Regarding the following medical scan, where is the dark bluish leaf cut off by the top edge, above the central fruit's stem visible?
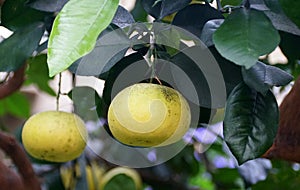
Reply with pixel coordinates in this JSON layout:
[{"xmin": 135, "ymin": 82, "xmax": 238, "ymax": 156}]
[{"xmin": 142, "ymin": 0, "xmax": 191, "ymax": 20}]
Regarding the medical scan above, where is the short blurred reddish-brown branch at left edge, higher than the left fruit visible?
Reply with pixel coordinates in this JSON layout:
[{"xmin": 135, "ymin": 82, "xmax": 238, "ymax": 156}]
[{"xmin": 0, "ymin": 64, "xmax": 26, "ymax": 99}]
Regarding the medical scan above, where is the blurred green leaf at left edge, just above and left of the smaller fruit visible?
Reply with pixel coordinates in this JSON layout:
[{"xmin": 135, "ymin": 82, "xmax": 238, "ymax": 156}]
[{"xmin": 0, "ymin": 93, "xmax": 30, "ymax": 118}]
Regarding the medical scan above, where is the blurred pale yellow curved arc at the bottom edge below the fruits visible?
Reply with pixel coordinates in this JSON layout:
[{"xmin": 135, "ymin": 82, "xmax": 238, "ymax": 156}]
[{"xmin": 100, "ymin": 167, "xmax": 142, "ymax": 190}]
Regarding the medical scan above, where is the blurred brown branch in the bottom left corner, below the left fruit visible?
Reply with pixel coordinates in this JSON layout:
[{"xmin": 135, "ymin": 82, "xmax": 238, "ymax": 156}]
[{"xmin": 0, "ymin": 132, "xmax": 41, "ymax": 190}]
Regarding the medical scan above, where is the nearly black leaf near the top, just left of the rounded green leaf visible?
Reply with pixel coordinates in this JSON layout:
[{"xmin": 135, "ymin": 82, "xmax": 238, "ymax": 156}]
[{"xmin": 172, "ymin": 4, "xmax": 224, "ymax": 37}]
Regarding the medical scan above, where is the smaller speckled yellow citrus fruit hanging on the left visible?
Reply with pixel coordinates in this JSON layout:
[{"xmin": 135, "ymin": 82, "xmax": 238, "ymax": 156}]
[{"xmin": 22, "ymin": 111, "xmax": 88, "ymax": 162}]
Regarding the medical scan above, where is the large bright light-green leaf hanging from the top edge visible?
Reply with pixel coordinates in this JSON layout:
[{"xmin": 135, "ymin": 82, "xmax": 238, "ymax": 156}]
[{"xmin": 48, "ymin": 0, "xmax": 119, "ymax": 76}]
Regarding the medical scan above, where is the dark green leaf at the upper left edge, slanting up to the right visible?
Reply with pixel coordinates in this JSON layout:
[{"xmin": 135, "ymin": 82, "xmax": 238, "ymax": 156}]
[{"xmin": 0, "ymin": 23, "xmax": 44, "ymax": 72}]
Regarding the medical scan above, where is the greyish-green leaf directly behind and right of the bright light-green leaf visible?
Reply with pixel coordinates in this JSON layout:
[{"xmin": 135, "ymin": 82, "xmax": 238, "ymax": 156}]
[{"xmin": 72, "ymin": 24, "xmax": 131, "ymax": 76}]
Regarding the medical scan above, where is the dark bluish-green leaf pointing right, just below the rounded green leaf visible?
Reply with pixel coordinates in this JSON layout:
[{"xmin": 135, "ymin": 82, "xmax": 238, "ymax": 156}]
[{"xmin": 242, "ymin": 62, "xmax": 293, "ymax": 94}]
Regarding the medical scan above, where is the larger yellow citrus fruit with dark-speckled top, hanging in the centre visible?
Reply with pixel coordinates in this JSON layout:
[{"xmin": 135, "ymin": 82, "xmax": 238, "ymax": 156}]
[{"xmin": 108, "ymin": 83, "xmax": 191, "ymax": 147}]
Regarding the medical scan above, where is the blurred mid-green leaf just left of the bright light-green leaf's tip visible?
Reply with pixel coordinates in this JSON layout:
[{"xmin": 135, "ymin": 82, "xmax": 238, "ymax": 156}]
[{"xmin": 26, "ymin": 54, "xmax": 55, "ymax": 96}]
